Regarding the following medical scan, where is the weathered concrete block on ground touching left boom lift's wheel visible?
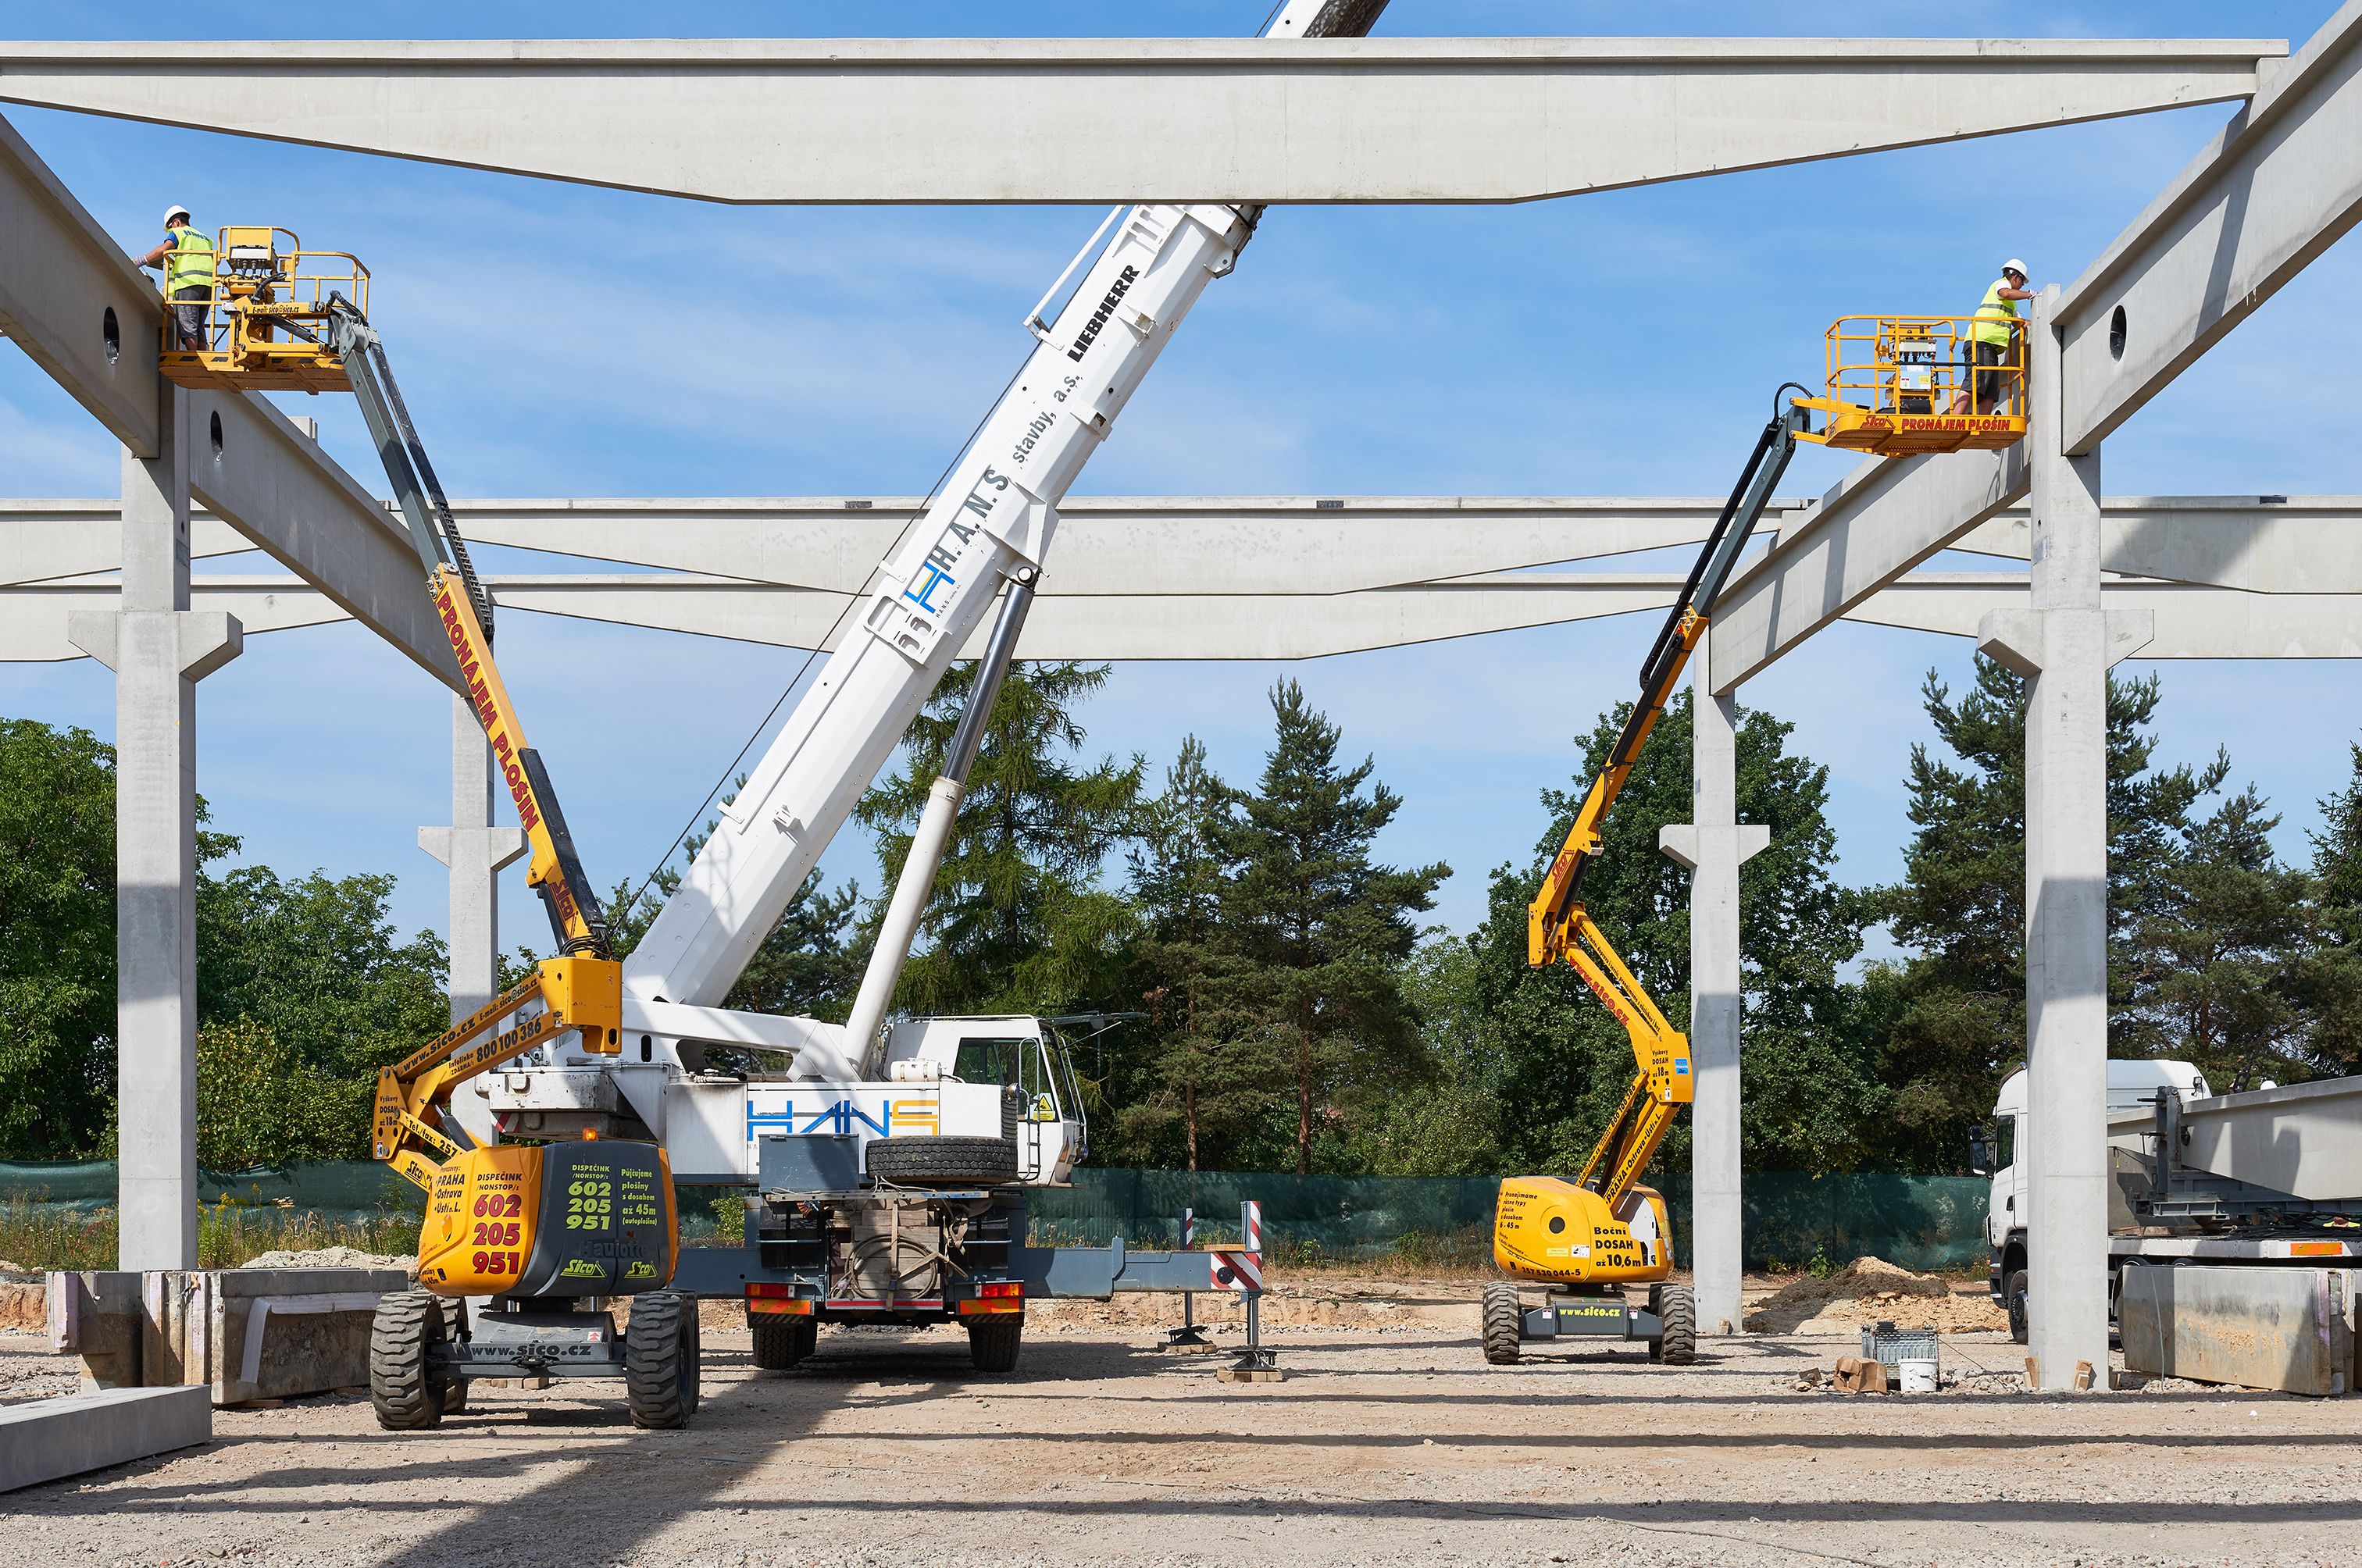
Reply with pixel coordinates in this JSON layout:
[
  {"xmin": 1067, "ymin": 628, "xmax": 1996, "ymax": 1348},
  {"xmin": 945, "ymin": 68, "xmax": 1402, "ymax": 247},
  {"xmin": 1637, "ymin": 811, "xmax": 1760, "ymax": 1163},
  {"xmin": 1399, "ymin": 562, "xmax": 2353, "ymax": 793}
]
[{"xmin": 141, "ymin": 1268, "xmax": 411, "ymax": 1405}]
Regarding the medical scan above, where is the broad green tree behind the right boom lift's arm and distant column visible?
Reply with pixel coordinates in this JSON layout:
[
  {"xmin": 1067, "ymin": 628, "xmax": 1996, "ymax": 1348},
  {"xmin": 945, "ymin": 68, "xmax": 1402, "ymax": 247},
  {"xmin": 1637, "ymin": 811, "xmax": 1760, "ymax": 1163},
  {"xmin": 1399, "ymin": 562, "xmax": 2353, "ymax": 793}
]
[{"xmin": 1469, "ymin": 692, "xmax": 1882, "ymax": 1174}]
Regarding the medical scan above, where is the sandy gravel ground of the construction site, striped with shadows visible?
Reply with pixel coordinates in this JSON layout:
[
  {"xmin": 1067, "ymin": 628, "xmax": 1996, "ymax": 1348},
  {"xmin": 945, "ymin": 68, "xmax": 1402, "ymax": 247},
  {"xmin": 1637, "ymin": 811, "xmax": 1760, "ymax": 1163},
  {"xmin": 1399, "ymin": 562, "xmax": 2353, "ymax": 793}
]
[{"xmin": 0, "ymin": 1278, "xmax": 2362, "ymax": 1568}]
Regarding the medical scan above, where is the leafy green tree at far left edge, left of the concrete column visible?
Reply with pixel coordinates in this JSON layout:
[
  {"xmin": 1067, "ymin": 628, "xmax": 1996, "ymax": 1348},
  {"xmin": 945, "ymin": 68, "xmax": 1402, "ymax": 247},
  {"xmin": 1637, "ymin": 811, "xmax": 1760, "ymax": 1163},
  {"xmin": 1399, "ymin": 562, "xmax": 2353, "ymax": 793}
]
[{"xmin": 0, "ymin": 718, "xmax": 116, "ymax": 1160}]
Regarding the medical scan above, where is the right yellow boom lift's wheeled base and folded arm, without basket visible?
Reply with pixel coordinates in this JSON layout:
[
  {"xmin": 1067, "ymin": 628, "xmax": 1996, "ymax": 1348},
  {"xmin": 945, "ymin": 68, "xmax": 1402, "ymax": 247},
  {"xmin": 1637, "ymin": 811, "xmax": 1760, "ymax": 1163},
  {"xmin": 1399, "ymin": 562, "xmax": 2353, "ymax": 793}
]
[{"xmin": 1483, "ymin": 387, "xmax": 1809, "ymax": 1365}]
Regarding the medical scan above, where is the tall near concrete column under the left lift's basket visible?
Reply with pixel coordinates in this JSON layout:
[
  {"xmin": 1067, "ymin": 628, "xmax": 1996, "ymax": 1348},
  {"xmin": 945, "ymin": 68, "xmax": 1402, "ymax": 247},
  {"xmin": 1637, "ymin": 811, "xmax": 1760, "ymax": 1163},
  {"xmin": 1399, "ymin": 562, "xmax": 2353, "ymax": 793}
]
[{"xmin": 66, "ymin": 385, "xmax": 243, "ymax": 1270}]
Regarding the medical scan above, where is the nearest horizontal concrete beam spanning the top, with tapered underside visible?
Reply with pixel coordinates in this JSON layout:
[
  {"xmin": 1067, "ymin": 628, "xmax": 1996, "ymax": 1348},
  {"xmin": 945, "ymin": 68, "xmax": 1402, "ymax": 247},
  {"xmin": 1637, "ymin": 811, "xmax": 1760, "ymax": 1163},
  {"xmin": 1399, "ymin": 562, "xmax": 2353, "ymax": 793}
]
[{"xmin": 0, "ymin": 37, "xmax": 2286, "ymax": 203}]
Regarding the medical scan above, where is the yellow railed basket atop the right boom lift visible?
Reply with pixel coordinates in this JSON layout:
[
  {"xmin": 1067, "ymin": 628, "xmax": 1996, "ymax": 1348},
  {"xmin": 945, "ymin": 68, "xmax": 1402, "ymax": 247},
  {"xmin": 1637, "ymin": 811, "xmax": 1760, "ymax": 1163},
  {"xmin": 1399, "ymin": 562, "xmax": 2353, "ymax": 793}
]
[{"xmin": 1795, "ymin": 316, "xmax": 2027, "ymax": 458}]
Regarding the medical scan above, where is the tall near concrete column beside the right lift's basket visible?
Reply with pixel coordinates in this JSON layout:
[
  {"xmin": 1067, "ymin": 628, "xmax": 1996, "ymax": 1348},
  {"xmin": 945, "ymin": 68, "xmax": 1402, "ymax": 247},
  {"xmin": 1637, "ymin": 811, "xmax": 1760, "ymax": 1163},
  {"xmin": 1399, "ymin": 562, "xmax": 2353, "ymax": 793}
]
[{"xmin": 1977, "ymin": 288, "xmax": 2152, "ymax": 1388}]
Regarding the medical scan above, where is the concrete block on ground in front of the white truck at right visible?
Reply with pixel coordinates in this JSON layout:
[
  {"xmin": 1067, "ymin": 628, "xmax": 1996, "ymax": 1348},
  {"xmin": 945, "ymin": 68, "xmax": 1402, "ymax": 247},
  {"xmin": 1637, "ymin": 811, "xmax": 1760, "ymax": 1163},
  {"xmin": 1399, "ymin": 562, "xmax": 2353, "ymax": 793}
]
[{"xmin": 2117, "ymin": 1268, "xmax": 2355, "ymax": 1395}]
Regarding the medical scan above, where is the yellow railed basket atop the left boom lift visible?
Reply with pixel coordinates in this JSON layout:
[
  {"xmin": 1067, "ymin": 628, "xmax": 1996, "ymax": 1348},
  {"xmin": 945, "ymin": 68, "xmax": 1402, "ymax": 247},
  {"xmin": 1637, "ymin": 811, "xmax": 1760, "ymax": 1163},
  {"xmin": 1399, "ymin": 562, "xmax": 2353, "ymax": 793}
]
[{"xmin": 156, "ymin": 224, "xmax": 369, "ymax": 394}]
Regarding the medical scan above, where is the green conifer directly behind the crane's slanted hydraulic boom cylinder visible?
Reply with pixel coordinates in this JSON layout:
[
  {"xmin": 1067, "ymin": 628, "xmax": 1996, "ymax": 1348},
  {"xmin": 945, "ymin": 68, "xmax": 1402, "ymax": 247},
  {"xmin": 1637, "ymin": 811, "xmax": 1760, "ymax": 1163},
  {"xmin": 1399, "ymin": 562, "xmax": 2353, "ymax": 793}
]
[{"xmin": 853, "ymin": 664, "xmax": 1148, "ymax": 1013}]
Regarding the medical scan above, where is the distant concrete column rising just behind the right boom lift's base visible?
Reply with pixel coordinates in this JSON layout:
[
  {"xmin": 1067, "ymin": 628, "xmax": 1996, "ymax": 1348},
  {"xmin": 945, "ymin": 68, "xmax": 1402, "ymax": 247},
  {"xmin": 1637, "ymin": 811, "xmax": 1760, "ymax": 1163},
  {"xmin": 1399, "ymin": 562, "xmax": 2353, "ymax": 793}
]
[{"xmin": 1656, "ymin": 633, "xmax": 1772, "ymax": 1335}]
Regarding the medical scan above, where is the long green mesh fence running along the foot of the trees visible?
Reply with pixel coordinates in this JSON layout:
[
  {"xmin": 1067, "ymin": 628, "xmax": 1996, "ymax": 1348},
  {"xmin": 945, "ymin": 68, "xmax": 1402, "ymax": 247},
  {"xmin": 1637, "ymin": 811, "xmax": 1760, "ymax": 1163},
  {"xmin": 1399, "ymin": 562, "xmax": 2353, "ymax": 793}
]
[{"xmin": 0, "ymin": 1160, "xmax": 1989, "ymax": 1268}]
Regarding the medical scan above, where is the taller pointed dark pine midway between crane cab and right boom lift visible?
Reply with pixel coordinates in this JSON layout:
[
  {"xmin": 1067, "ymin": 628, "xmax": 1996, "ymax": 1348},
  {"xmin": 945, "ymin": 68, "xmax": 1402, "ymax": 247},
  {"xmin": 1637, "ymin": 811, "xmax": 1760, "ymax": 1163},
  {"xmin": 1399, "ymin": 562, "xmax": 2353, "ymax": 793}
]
[{"xmin": 1214, "ymin": 680, "xmax": 1453, "ymax": 1176}]
